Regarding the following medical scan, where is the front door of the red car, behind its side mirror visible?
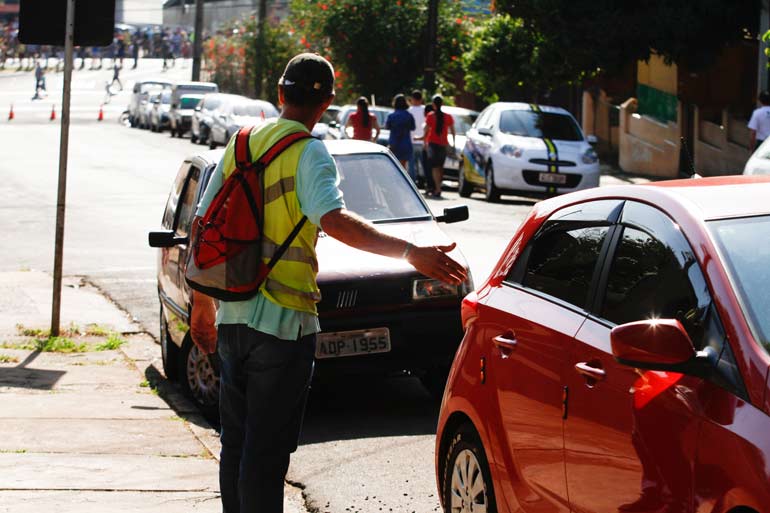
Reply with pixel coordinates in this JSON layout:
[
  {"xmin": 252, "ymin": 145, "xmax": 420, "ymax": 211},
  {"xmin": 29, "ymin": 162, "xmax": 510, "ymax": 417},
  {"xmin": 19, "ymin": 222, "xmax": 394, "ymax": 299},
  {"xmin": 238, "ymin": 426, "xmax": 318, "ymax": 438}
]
[{"xmin": 564, "ymin": 201, "xmax": 739, "ymax": 513}]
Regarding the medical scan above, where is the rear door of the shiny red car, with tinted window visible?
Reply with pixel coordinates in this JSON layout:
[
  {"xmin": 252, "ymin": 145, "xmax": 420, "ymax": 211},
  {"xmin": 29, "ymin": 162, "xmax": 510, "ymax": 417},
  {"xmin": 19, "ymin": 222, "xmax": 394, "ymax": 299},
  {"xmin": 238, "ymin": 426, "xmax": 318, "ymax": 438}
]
[{"xmin": 480, "ymin": 201, "xmax": 621, "ymax": 513}]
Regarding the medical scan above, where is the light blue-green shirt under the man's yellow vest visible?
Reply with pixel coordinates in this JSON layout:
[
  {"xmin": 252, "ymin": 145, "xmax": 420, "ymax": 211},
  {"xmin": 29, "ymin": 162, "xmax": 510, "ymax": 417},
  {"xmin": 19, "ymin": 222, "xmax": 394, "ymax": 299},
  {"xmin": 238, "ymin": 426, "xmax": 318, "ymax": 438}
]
[{"xmin": 196, "ymin": 118, "xmax": 345, "ymax": 340}]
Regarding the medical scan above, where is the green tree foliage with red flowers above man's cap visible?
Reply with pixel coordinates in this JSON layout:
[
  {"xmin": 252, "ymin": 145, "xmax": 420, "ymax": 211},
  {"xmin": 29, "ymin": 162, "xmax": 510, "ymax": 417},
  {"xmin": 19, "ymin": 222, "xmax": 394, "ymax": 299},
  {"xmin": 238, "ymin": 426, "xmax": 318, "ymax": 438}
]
[{"xmin": 291, "ymin": 0, "xmax": 471, "ymax": 103}]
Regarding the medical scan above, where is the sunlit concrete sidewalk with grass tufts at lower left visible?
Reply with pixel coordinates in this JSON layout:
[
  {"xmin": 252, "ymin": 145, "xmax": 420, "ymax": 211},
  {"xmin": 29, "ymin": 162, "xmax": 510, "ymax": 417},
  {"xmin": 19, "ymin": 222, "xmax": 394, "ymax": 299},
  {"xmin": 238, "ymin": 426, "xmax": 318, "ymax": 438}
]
[{"xmin": 0, "ymin": 272, "xmax": 305, "ymax": 513}]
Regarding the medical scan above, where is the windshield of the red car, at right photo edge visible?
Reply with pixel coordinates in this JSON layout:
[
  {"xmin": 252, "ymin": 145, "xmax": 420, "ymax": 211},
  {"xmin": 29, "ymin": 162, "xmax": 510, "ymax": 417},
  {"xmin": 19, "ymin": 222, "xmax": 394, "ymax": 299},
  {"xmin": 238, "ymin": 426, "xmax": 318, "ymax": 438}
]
[{"xmin": 708, "ymin": 216, "xmax": 770, "ymax": 352}]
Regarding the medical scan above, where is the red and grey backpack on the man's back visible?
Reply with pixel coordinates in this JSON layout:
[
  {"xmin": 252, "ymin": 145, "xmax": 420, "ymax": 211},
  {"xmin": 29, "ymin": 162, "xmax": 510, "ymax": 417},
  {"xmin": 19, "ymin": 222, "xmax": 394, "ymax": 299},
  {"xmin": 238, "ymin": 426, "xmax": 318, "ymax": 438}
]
[{"xmin": 185, "ymin": 127, "xmax": 311, "ymax": 301}]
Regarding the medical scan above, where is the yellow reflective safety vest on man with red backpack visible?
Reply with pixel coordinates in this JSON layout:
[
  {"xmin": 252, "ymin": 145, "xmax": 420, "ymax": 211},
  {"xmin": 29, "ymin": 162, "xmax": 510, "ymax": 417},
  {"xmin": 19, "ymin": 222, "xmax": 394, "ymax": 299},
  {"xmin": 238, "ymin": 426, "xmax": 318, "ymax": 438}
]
[{"xmin": 223, "ymin": 119, "xmax": 321, "ymax": 314}]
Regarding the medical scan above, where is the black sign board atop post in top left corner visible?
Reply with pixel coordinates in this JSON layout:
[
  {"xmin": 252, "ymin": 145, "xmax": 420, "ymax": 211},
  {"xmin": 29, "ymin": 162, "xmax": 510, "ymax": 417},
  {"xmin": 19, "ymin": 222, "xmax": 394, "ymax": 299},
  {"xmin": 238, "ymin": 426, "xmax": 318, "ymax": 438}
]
[{"xmin": 19, "ymin": 0, "xmax": 115, "ymax": 46}]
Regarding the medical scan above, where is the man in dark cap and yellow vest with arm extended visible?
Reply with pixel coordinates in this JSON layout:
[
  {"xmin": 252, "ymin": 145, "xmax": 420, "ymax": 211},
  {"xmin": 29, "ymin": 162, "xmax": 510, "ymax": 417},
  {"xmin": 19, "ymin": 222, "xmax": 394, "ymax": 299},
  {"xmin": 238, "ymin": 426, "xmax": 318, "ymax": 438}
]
[{"xmin": 190, "ymin": 53, "xmax": 467, "ymax": 513}]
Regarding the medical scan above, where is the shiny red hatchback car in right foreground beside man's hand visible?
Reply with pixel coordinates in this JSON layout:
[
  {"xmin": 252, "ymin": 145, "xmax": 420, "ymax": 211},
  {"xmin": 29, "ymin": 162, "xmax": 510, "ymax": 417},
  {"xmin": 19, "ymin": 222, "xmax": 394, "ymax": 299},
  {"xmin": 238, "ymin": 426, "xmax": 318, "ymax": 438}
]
[{"xmin": 436, "ymin": 177, "xmax": 770, "ymax": 513}]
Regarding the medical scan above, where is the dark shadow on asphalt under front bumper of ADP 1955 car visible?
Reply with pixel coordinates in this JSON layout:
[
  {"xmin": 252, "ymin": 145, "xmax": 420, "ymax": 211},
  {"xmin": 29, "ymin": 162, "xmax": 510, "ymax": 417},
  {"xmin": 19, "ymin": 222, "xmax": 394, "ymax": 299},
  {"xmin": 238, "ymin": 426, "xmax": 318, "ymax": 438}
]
[{"xmin": 300, "ymin": 376, "xmax": 439, "ymax": 445}]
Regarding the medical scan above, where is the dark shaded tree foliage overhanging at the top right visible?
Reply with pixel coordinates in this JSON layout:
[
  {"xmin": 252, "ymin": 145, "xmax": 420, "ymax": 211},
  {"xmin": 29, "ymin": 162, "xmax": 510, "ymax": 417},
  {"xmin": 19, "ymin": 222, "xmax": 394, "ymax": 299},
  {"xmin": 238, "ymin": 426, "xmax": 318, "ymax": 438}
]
[{"xmin": 496, "ymin": 0, "xmax": 760, "ymax": 73}]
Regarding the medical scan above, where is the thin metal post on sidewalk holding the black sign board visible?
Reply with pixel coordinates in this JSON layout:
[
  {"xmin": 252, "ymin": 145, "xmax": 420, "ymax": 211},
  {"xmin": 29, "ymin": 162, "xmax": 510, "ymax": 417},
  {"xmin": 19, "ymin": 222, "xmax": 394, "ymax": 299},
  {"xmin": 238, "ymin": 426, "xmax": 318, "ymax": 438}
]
[{"xmin": 51, "ymin": 0, "xmax": 75, "ymax": 337}]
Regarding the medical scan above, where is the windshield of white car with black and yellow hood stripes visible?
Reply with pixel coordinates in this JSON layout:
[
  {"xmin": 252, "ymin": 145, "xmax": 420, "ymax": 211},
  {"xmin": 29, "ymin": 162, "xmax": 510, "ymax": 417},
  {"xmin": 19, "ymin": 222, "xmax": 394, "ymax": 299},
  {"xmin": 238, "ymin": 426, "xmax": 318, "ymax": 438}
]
[{"xmin": 500, "ymin": 110, "xmax": 583, "ymax": 141}]
